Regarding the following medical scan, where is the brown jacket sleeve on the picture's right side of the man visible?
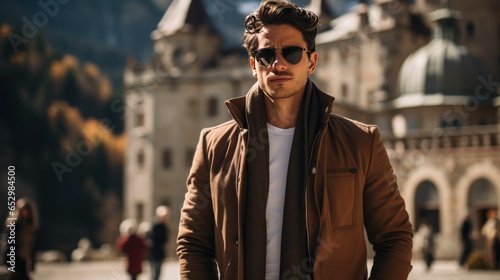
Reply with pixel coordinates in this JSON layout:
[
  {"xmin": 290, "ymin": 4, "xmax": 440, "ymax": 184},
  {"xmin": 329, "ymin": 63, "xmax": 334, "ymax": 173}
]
[{"xmin": 363, "ymin": 126, "xmax": 413, "ymax": 280}]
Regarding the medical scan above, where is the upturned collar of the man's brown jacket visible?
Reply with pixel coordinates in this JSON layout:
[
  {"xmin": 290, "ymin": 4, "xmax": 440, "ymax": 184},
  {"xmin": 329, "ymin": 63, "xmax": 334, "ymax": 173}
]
[{"xmin": 225, "ymin": 79, "xmax": 335, "ymax": 129}]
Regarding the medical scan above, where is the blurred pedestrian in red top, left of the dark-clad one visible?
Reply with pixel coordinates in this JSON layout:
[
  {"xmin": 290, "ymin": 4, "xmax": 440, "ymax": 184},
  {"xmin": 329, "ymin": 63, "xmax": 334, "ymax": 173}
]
[{"xmin": 116, "ymin": 219, "xmax": 148, "ymax": 280}]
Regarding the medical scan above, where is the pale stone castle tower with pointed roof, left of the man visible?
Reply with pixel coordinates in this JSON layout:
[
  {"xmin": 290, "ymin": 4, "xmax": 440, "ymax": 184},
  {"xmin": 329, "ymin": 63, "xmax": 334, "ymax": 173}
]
[{"xmin": 124, "ymin": 0, "xmax": 255, "ymax": 255}]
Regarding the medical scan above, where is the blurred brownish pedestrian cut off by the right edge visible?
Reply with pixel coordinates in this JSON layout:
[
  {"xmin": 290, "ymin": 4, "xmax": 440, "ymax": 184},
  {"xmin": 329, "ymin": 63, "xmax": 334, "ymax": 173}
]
[{"xmin": 481, "ymin": 209, "xmax": 500, "ymax": 269}]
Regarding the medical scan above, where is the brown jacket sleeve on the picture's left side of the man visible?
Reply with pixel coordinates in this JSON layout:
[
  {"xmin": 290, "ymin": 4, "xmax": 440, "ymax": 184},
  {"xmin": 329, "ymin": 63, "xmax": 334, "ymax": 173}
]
[{"xmin": 177, "ymin": 131, "xmax": 218, "ymax": 280}]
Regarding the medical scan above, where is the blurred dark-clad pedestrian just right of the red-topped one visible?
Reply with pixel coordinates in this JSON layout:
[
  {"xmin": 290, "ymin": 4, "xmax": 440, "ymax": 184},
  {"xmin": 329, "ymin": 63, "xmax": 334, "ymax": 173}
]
[{"xmin": 149, "ymin": 205, "xmax": 170, "ymax": 280}]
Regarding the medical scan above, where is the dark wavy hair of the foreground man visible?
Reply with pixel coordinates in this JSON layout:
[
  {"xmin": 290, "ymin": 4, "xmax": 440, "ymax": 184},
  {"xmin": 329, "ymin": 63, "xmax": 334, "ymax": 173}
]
[{"xmin": 242, "ymin": 0, "xmax": 319, "ymax": 55}]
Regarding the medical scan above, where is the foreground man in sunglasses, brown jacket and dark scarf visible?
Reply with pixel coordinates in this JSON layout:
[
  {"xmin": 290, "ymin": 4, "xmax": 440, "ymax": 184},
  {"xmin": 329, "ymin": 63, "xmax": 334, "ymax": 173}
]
[{"xmin": 177, "ymin": 1, "xmax": 413, "ymax": 280}]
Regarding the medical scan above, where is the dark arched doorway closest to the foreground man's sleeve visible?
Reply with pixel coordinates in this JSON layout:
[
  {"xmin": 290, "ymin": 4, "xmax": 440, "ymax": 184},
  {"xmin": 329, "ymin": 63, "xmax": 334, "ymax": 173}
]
[{"xmin": 414, "ymin": 181, "xmax": 441, "ymax": 233}]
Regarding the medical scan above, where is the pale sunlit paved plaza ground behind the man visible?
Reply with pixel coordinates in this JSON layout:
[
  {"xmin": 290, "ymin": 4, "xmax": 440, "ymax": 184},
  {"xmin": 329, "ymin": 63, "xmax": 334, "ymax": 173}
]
[{"xmin": 0, "ymin": 260, "xmax": 500, "ymax": 280}]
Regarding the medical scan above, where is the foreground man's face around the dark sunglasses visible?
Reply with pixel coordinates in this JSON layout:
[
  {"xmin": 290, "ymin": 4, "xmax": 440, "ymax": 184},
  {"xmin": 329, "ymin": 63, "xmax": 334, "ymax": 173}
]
[{"xmin": 250, "ymin": 24, "xmax": 318, "ymax": 99}]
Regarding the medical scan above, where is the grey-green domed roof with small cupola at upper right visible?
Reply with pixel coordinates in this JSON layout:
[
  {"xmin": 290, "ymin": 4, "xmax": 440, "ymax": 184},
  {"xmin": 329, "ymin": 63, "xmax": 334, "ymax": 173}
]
[{"xmin": 398, "ymin": 5, "xmax": 488, "ymax": 105}]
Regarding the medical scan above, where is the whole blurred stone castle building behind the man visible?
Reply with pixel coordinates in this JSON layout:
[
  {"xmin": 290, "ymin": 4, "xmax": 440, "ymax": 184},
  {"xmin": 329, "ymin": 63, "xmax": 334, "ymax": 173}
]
[{"xmin": 124, "ymin": 0, "xmax": 500, "ymax": 258}]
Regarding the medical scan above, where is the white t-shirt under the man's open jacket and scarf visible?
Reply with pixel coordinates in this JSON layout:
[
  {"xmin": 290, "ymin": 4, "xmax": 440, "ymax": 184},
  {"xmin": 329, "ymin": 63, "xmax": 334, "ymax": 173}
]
[{"xmin": 266, "ymin": 124, "xmax": 295, "ymax": 280}]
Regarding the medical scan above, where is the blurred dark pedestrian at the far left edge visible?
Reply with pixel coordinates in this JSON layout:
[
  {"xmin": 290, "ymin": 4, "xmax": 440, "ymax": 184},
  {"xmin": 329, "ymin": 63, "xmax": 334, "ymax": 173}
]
[{"xmin": 2, "ymin": 198, "xmax": 38, "ymax": 280}]
